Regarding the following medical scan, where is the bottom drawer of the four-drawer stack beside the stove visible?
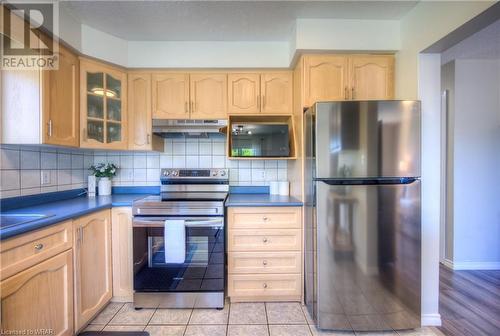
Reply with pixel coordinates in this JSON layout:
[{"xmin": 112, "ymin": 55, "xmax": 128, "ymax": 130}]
[{"xmin": 228, "ymin": 274, "xmax": 302, "ymax": 302}]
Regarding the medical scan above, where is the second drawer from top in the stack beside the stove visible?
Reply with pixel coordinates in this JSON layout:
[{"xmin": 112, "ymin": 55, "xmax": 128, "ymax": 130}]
[{"xmin": 228, "ymin": 229, "xmax": 302, "ymax": 252}]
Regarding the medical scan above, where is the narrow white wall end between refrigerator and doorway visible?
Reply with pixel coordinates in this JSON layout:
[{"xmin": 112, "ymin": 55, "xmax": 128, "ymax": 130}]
[{"xmin": 418, "ymin": 54, "xmax": 441, "ymax": 325}]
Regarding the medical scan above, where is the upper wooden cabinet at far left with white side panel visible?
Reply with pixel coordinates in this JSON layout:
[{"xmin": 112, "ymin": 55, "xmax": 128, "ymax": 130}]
[{"xmin": 0, "ymin": 45, "xmax": 80, "ymax": 147}]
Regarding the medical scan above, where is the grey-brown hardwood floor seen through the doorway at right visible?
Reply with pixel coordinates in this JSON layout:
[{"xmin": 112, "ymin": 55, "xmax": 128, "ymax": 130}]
[{"xmin": 439, "ymin": 265, "xmax": 500, "ymax": 336}]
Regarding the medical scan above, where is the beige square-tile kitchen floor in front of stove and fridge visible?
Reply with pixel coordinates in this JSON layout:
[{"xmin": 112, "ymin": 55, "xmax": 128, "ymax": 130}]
[{"xmin": 85, "ymin": 302, "xmax": 443, "ymax": 336}]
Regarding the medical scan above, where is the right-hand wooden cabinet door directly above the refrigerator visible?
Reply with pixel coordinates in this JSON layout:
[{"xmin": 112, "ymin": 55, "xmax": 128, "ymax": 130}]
[{"xmin": 349, "ymin": 55, "xmax": 394, "ymax": 100}]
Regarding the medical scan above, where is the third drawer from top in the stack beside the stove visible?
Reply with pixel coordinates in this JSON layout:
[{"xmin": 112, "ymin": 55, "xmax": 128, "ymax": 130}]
[{"xmin": 227, "ymin": 252, "xmax": 301, "ymax": 274}]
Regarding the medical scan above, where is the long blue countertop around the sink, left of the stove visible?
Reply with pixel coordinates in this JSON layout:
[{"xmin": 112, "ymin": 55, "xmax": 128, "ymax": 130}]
[{"xmin": 0, "ymin": 194, "xmax": 148, "ymax": 240}]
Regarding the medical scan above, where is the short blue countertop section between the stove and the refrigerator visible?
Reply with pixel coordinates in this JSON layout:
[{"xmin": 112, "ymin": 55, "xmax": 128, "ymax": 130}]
[{"xmin": 226, "ymin": 194, "xmax": 302, "ymax": 207}]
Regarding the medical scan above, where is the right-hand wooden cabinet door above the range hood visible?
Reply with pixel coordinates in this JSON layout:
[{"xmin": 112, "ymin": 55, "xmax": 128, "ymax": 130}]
[{"xmin": 190, "ymin": 73, "xmax": 227, "ymax": 119}]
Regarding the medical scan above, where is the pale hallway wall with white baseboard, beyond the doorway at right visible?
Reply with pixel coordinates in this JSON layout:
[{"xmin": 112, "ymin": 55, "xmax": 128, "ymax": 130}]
[{"xmin": 453, "ymin": 60, "xmax": 500, "ymax": 269}]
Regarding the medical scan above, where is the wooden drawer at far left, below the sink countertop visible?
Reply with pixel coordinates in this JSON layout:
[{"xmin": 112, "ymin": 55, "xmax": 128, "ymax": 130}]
[{"xmin": 0, "ymin": 221, "xmax": 73, "ymax": 280}]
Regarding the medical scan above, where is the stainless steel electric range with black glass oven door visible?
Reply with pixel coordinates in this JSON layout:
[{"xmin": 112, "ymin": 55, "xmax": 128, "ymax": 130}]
[{"xmin": 132, "ymin": 169, "xmax": 229, "ymax": 308}]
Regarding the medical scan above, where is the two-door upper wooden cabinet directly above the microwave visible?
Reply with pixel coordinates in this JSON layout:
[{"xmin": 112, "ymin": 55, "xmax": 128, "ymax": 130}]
[{"xmin": 228, "ymin": 72, "xmax": 292, "ymax": 114}]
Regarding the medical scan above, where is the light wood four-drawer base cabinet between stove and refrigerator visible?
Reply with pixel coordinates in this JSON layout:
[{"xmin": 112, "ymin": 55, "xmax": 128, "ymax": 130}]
[{"xmin": 227, "ymin": 207, "xmax": 302, "ymax": 302}]
